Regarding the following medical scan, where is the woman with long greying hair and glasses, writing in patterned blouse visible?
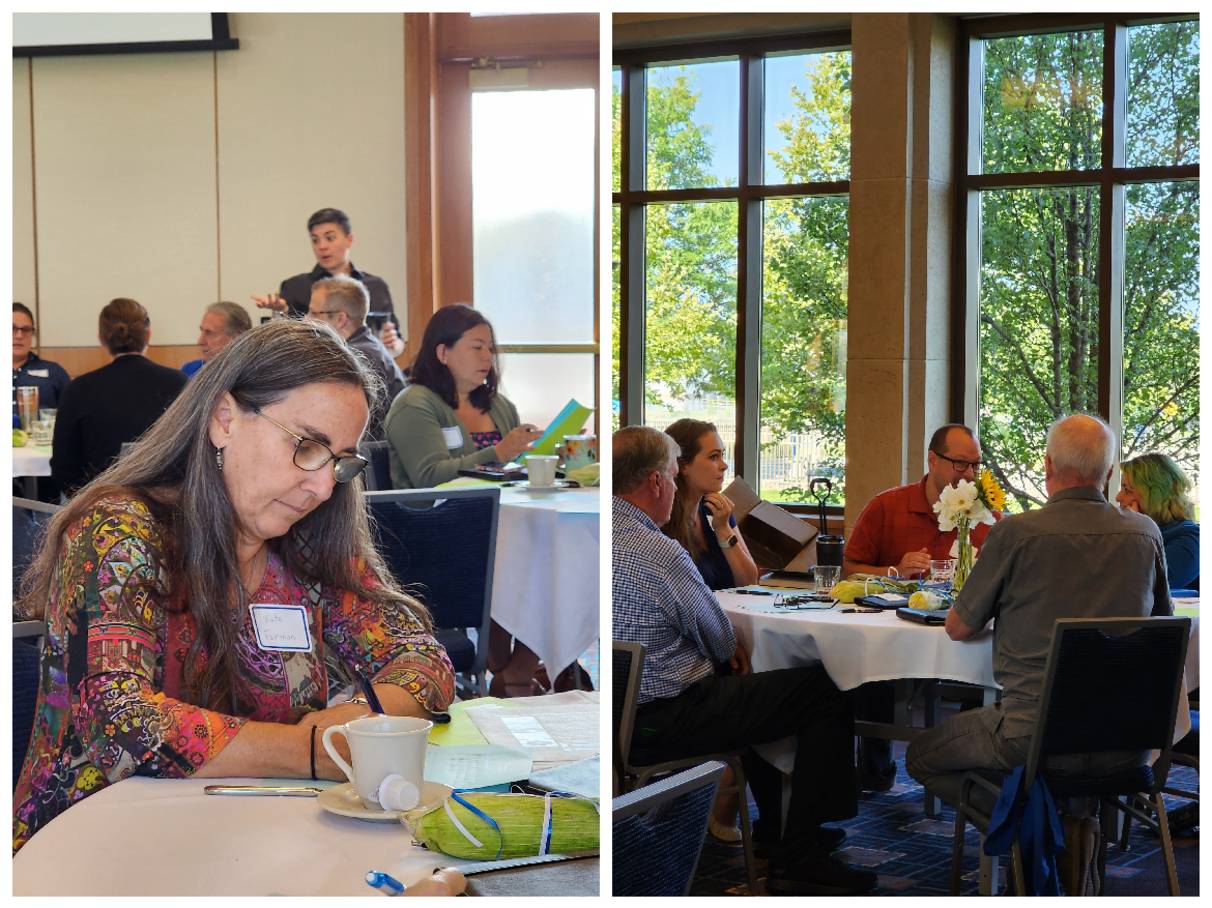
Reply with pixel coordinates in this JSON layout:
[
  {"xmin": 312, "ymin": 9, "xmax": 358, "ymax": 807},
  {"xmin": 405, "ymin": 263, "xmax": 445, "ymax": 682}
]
[{"xmin": 13, "ymin": 320, "xmax": 455, "ymax": 887}]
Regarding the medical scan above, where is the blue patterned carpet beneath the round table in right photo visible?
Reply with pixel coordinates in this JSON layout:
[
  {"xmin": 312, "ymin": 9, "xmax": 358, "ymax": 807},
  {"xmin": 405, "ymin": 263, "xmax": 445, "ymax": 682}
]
[{"xmin": 690, "ymin": 744, "xmax": 1199, "ymax": 896}]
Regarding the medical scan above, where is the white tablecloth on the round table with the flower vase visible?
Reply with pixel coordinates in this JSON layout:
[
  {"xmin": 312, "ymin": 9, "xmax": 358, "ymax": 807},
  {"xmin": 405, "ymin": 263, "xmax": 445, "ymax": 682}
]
[{"xmin": 718, "ymin": 592, "xmax": 997, "ymax": 691}]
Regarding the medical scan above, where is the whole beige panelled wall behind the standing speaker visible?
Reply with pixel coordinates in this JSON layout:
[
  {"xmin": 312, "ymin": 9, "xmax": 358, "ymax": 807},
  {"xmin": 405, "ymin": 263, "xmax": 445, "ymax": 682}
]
[{"xmin": 13, "ymin": 13, "xmax": 405, "ymax": 359}]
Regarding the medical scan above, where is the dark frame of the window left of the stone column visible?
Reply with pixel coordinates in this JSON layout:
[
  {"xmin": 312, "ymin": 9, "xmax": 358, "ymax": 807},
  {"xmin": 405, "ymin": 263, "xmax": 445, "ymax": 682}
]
[{"xmin": 612, "ymin": 29, "xmax": 851, "ymax": 513}]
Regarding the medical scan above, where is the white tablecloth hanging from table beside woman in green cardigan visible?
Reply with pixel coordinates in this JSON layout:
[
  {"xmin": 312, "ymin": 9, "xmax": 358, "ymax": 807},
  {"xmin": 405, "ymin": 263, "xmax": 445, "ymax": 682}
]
[{"xmin": 492, "ymin": 487, "xmax": 601, "ymax": 678}]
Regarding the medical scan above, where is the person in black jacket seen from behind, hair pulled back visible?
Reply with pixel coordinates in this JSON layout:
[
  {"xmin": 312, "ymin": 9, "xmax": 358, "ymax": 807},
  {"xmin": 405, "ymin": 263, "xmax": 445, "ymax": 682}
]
[{"xmin": 51, "ymin": 298, "xmax": 189, "ymax": 496}]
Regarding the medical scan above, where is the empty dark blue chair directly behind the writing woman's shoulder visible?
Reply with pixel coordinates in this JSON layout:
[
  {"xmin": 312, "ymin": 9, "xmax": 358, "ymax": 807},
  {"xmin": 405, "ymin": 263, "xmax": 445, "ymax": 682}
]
[{"xmin": 366, "ymin": 487, "xmax": 501, "ymax": 696}]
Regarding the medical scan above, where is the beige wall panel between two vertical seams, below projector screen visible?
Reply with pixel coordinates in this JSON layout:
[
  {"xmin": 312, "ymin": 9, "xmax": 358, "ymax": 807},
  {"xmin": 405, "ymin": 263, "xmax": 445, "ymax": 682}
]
[{"xmin": 33, "ymin": 53, "xmax": 218, "ymax": 346}]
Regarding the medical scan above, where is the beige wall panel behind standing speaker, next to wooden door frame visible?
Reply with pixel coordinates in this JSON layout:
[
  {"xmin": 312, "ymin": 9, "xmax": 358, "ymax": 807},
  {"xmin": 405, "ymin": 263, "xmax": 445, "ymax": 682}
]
[{"xmin": 217, "ymin": 13, "xmax": 406, "ymax": 337}]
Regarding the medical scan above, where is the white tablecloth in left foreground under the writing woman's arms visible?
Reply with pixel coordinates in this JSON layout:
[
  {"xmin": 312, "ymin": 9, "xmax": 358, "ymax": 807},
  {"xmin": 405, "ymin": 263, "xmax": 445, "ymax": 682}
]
[{"xmin": 12, "ymin": 777, "xmax": 450, "ymax": 898}]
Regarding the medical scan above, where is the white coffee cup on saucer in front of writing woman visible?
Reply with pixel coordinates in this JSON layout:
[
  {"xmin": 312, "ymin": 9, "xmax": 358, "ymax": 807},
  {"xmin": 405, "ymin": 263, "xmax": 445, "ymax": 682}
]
[{"xmin": 324, "ymin": 715, "xmax": 434, "ymax": 810}]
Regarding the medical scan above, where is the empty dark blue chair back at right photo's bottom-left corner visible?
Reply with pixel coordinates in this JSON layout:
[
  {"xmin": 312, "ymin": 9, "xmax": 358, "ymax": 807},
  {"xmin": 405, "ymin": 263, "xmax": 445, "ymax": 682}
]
[{"xmin": 611, "ymin": 761, "xmax": 724, "ymax": 896}]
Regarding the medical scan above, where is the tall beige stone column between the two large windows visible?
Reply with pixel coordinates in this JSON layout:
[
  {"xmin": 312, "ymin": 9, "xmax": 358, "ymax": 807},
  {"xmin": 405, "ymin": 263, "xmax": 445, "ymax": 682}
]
[{"xmin": 846, "ymin": 13, "xmax": 955, "ymax": 531}]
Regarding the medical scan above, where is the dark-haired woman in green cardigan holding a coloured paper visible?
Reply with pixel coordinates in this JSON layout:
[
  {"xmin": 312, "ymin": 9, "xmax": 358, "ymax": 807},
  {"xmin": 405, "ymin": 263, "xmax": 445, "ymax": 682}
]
[{"xmin": 383, "ymin": 303, "xmax": 542, "ymax": 696}]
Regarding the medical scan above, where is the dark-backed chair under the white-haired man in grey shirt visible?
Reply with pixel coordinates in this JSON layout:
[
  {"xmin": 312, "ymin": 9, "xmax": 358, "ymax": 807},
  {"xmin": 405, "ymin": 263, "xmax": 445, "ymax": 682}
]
[{"xmin": 930, "ymin": 617, "xmax": 1190, "ymax": 896}]
